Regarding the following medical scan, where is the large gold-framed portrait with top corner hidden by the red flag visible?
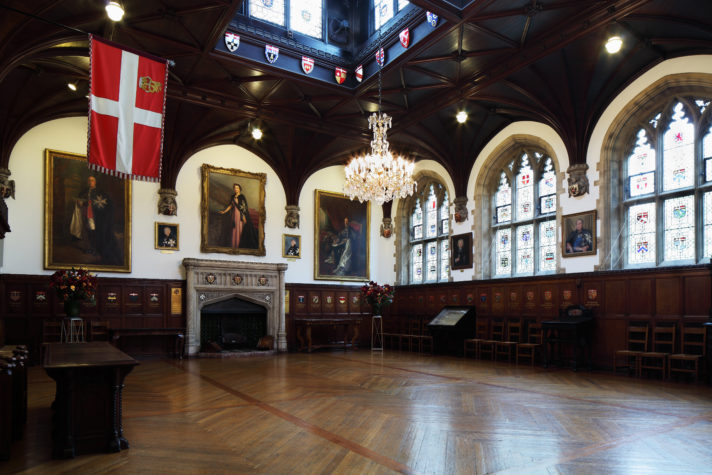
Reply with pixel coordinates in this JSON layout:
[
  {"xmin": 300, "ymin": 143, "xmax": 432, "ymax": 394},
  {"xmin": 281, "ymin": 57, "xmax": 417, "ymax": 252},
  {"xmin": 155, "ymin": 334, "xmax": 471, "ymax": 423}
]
[{"xmin": 44, "ymin": 150, "xmax": 131, "ymax": 272}]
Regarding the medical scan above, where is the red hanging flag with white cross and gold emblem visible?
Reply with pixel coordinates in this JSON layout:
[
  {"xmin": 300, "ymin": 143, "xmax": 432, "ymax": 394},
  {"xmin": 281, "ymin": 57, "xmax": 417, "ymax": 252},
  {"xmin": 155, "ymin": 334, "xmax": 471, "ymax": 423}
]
[{"xmin": 87, "ymin": 35, "xmax": 168, "ymax": 182}]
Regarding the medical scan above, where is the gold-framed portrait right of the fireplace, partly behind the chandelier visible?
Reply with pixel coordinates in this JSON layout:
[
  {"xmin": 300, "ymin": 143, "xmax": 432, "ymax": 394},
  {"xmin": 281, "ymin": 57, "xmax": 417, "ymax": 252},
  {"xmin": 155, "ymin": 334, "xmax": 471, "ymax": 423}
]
[{"xmin": 314, "ymin": 190, "xmax": 371, "ymax": 281}]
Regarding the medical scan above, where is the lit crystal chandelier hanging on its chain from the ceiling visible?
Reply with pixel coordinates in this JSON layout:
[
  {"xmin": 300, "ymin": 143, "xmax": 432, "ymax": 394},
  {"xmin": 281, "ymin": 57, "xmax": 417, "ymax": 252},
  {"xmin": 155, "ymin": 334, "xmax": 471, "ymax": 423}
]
[{"xmin": 344, "ymin": 30, "xmax": 417, "ymax": 205}]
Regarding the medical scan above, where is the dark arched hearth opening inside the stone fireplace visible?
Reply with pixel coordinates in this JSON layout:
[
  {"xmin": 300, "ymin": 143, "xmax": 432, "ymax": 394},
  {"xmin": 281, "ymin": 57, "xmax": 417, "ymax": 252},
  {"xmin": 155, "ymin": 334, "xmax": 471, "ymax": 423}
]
[{"xmin": 200, "ymin": 297, "xmax": 267, "ymax": 353}]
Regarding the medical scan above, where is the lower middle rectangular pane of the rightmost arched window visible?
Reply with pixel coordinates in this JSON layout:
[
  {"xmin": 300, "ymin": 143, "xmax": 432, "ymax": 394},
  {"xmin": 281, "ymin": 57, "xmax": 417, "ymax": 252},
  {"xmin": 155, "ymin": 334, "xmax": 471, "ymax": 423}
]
[{"xmin": 663, "ymin": 195, "xmax": 695, "ymax": 261}]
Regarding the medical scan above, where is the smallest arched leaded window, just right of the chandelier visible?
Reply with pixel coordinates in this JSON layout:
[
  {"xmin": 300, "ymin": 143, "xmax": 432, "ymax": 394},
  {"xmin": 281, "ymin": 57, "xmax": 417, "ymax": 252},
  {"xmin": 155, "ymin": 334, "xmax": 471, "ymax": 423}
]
[{"xmin": 407, "ymin": 181, "xmax": 450, "ymax": 284}]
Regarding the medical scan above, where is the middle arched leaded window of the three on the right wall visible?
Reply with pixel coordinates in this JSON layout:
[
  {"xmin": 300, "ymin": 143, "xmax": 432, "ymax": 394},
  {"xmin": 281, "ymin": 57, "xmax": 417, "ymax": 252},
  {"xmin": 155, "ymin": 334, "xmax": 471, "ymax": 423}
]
[{"xmin": 492, "ymin": 151, "xmax": 558, "ymax": 277}]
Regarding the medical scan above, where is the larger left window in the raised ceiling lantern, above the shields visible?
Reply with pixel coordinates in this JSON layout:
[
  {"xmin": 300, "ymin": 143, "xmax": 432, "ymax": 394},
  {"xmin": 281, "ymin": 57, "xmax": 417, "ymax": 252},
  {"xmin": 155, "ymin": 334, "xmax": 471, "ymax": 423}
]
[{"xmin": 249, "ymin": 0, "xmax": 323, "ymax": 38}]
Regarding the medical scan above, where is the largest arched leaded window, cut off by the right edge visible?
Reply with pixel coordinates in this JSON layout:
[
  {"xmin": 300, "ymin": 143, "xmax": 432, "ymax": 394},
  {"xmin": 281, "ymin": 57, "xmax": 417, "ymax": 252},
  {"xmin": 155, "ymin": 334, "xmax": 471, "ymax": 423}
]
[{"xmin": 612, "ymin": 97, "xmax": 712, "ymax": 267}]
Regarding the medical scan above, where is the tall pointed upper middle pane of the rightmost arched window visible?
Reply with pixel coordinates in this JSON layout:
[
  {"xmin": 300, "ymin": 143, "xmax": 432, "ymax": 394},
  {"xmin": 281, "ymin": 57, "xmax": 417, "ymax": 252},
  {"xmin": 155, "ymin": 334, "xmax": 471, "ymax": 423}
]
[{"xmin": 663, "ymin": 103, "xmax": 695, "ymax": 191}]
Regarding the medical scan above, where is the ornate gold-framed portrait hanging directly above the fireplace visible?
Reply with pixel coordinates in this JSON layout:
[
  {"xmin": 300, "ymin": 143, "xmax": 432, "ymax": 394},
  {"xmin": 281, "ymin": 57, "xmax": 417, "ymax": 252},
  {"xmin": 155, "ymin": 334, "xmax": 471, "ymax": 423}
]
[{"xmin": 200, "ymin": 165, "xmax": 267, "ymax": 256}]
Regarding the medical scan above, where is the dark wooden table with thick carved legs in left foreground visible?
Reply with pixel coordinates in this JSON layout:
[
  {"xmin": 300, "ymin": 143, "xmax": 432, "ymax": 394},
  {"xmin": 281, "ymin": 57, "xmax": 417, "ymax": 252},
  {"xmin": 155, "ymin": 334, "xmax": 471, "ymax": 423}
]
[{"xmin": 42, "ymin": 341, "xmax": 138, "ymax": 458}]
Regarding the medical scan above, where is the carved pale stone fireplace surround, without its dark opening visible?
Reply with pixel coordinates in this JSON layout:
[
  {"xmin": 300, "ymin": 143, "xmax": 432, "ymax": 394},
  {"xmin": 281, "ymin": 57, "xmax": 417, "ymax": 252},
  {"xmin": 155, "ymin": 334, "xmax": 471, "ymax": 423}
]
[{"xmin": 183, "ymin": 258, "xmax": 287, "ymax": 355}]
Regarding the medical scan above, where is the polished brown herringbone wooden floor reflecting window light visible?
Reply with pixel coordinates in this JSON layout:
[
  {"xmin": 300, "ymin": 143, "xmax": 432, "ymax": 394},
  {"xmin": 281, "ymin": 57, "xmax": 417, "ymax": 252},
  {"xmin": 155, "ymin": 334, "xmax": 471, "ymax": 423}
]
[{"xmin": 0, "ymin": 351, "xmax": 712, "ymax": 474}]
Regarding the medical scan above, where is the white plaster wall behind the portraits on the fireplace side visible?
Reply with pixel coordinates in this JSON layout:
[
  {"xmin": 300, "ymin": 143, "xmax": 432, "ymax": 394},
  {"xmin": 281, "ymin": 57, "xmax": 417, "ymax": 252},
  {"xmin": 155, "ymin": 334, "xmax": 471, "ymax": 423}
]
[{"xmin": 0, "ymin": 118, "xmax": 395, "ymax": 285}]
